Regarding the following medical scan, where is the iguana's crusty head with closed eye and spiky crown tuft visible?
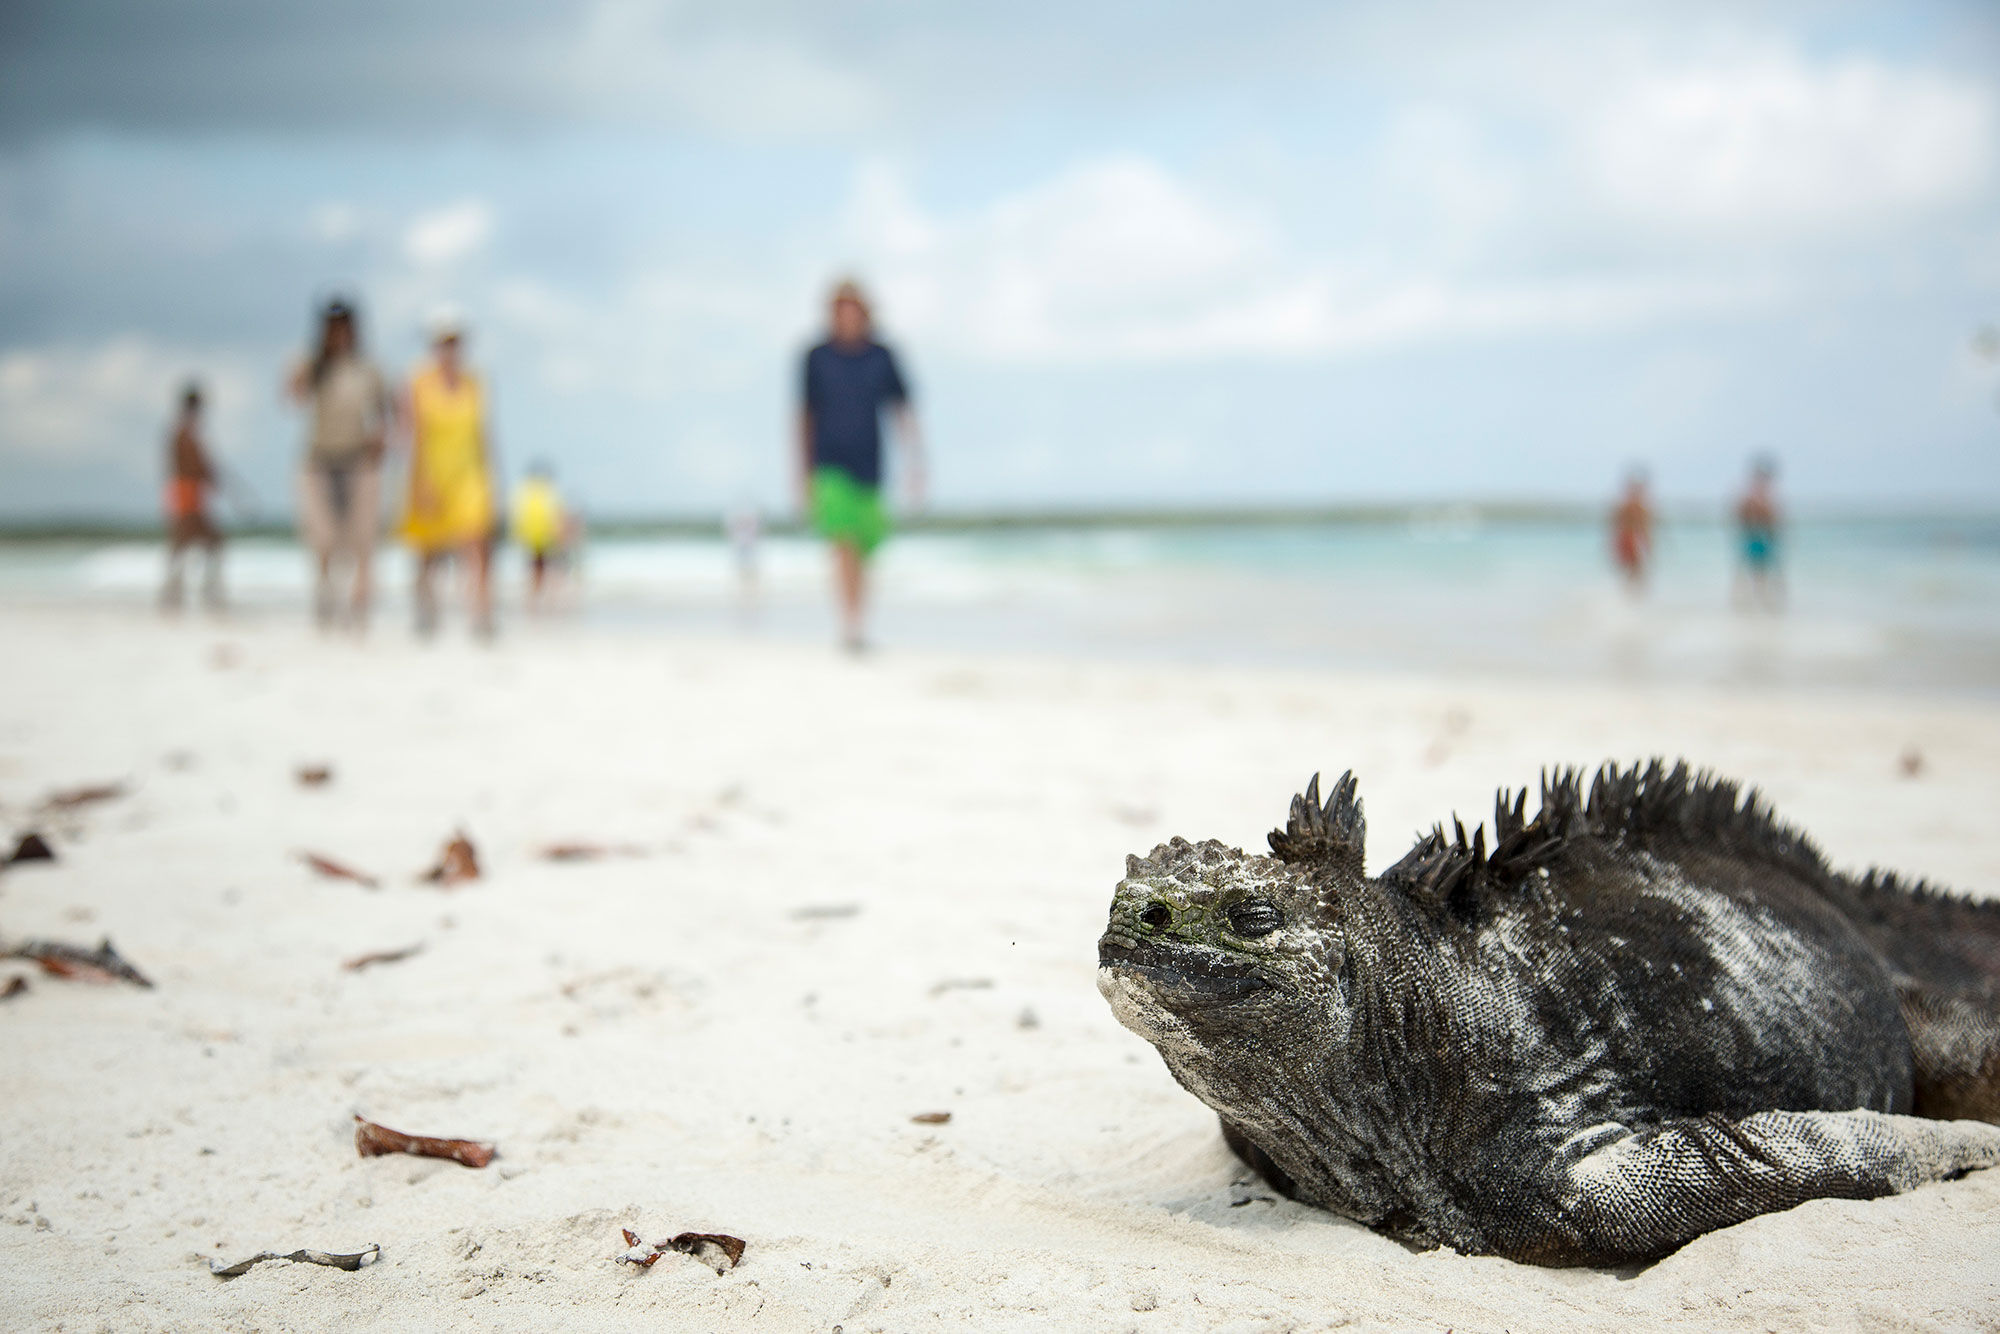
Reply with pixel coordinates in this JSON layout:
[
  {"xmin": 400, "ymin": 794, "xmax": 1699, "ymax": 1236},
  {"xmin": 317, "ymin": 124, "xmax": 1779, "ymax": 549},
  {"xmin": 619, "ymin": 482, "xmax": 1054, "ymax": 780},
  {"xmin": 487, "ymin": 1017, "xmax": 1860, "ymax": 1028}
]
[{"xmin": 1098, "ymin": 778, "xmax": 1360, "ymax": 1078}]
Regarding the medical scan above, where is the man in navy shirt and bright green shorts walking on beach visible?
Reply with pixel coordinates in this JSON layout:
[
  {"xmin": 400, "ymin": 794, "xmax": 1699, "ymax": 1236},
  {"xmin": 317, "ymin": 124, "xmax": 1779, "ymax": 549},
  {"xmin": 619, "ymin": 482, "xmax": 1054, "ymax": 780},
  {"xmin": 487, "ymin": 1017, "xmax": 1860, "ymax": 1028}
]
[{"xmin": 798, "ymin": 282, "xmax": 924, "ymax": 652}]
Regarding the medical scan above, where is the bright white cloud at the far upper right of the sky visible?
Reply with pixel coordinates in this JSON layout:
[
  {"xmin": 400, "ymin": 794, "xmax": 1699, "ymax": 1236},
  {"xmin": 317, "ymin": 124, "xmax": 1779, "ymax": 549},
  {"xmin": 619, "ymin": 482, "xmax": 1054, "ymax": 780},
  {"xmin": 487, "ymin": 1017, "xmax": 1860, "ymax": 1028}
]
[{"xmin": 1584, "ymin": 52, "xmax": 1996, "ymax": 230}]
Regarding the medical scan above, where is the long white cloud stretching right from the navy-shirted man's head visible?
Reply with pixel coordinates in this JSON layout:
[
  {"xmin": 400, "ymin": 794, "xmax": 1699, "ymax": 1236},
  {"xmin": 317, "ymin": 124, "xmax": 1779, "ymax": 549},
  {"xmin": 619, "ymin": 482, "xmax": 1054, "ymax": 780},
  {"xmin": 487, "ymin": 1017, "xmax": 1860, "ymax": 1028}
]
[{"xmin": 848, "ymin": 158, "xmax": 1782, "ymax": 362}]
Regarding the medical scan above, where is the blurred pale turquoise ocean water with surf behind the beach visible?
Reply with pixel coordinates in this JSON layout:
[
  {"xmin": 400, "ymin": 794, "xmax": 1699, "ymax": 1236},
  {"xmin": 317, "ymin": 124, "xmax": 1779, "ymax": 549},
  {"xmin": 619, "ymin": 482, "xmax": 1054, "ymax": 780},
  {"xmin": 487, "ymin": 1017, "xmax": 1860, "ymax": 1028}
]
[{"xmin": 0, "ymin": 514, "xmax": 2000, "ymax": 694}]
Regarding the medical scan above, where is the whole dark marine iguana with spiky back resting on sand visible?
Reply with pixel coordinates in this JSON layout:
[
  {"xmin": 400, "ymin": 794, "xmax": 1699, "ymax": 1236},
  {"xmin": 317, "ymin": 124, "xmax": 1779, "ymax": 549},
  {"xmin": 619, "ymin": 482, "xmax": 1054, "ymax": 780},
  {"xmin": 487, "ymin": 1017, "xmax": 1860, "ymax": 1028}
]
[{"xmin": 1098, "ymin": 760, "xmax": 2000, "ymax": 1266}]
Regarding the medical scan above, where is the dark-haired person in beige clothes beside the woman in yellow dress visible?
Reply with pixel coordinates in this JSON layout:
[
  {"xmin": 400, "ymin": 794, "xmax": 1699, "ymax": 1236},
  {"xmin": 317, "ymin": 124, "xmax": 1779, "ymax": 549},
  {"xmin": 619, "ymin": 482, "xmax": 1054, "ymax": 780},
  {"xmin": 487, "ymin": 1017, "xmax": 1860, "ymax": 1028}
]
[{"xmin": 288, "ymin": 298, "xmax": 394, "ymax": 632}]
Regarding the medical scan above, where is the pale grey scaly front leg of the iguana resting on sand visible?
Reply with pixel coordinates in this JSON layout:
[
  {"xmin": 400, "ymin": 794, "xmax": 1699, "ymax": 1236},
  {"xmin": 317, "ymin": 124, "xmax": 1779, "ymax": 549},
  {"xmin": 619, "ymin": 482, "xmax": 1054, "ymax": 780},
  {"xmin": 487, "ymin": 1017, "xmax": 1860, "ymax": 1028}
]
[{"xmin": 1496, "ymin": 1112, "xmax": 2000, "ymax": 1264}]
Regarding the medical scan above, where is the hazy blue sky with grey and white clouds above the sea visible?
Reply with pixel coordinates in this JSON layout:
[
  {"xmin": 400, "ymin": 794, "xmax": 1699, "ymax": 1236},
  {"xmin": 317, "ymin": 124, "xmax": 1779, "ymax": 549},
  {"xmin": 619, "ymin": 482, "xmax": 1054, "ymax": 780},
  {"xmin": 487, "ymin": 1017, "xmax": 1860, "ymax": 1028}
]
[{"xmin": 0, "ymin": 0, "xmax": 2000, "ymax": 516}]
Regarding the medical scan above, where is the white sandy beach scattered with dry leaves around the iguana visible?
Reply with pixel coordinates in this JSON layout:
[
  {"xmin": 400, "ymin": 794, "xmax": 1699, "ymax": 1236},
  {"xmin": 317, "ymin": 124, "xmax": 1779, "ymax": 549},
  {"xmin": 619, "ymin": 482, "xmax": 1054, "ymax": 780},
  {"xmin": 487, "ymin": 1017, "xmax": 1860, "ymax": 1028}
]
[{"xmin": 0, "ymin": 610, "xmax": 2000, "ymax": 1332}]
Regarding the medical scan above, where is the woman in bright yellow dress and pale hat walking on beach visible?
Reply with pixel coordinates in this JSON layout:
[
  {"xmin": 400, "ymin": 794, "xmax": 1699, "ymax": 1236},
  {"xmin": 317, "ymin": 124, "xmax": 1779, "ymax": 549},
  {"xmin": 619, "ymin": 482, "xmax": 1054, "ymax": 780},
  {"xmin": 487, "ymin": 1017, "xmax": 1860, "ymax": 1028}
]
[{"xmin": 402, "ymin": 320, "xmax": 494, "ymax": 636}]
